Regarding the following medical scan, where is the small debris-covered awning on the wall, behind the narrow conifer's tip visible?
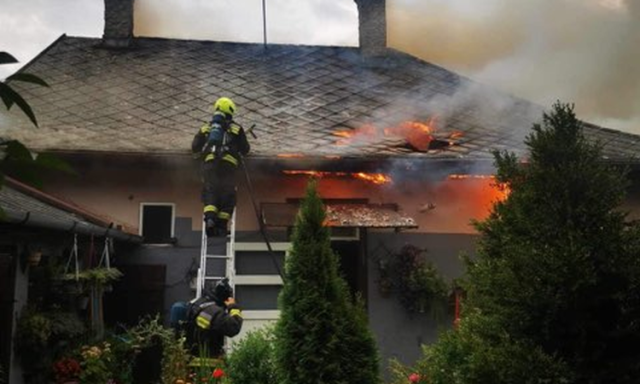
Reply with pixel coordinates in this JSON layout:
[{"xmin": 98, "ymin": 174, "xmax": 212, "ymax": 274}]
[{"xmin": 261, "ymin": 203, "xmax": 418, "ymax": 229}]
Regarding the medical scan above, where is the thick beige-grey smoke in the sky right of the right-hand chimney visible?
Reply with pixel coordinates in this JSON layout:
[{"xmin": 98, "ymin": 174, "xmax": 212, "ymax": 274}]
[{"xmin": 387, "ymin": 0, "xmax": 640, "ymax": 133}]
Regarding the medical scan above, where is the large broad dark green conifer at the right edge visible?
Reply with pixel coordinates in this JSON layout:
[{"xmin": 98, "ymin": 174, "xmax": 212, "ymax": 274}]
[{"xmin": 398, "ymin": 103, "xmax": 640, "ymax": 384}]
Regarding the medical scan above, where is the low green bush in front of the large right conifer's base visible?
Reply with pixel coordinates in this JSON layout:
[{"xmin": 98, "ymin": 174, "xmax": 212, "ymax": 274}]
[{"xmin": 391, "ymin": 315, "xmax": 572, "ymax": 384}]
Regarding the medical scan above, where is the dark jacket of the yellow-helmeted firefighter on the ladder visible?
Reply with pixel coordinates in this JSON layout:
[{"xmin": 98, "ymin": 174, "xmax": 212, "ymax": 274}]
[{"xmin": 191, "ymin": 112, "xmax": 250, "ymax": 166}]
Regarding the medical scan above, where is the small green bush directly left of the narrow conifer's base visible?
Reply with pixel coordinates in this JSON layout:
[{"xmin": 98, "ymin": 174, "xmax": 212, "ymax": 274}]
[{"xmin": 227, "ymin": 327, "xmax": 278, "ymax": 384}]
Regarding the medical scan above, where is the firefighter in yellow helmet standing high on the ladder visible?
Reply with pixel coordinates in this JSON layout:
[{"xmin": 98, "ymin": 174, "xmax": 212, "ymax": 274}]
[{"xmin": 191, "ymin": 97, "xmax": 250, "ymax": 236}]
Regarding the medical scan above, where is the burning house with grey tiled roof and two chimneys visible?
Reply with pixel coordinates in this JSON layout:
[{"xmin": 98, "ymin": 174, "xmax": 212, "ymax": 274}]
[{"xmin": 1, "ymin": 0, "xmax": 640, "ymax": 376}]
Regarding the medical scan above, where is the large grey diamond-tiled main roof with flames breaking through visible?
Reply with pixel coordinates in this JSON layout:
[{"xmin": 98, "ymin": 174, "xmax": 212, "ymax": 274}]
[{"xmin": 0, "ymin": 36, "xmax": 640, "ymax": 161}]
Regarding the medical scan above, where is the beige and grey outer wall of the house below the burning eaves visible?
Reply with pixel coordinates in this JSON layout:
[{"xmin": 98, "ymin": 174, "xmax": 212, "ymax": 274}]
[{"xmin": 38, "ymin": 162, "xmax": 640, "ymax": 372}]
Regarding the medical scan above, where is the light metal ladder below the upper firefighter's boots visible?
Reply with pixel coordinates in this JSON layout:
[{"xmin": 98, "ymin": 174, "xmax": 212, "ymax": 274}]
[{"xmin": 196, "ymin": 209, "xmax": 236, "ymax": 299}]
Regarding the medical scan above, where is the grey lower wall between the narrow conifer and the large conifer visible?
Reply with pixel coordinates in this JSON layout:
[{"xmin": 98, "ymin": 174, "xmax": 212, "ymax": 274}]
[{"xmin": 367, "ymin": 232, "xmax": 477, "ymax": 370}]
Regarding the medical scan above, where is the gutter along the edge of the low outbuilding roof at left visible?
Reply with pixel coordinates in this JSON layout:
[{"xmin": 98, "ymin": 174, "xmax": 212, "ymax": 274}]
[{"xmin": 4, "ymin": 208, "xmax": 142, "ymax": 244}]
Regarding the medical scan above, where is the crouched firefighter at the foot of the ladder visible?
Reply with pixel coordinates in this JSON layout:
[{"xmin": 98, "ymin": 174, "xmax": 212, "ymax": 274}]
[{"xmin": 171, "ymin": 278, "xmax": 242, "ymax": 358}]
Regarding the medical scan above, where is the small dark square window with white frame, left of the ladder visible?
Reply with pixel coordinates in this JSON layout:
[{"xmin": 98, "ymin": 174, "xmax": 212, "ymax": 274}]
[{"xmin": 140, "ymin": 203, "xmax": 175, "ymax": 244}]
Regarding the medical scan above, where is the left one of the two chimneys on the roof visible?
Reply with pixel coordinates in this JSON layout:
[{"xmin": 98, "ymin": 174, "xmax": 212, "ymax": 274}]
[{"xmin": 102, "ymin": 0, "xmax": 134, "ymax": 48}]
